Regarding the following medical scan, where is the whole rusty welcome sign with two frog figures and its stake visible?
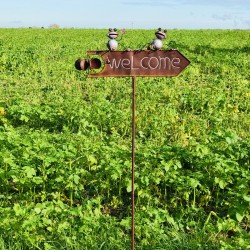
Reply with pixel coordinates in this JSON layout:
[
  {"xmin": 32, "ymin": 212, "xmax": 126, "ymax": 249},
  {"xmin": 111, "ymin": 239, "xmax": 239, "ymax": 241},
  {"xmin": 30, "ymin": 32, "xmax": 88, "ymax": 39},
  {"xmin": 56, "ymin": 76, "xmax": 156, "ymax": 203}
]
[{"xmin": 75, "ymin": 28, "xmax": 190, "ymax": 250}]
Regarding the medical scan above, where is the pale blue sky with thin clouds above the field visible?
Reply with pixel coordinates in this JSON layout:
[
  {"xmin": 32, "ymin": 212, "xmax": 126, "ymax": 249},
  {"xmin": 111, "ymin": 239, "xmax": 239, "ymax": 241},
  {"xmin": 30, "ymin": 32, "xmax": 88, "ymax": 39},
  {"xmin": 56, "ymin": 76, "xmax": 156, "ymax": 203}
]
[{"xmin": 0, "ymin": 0, "xmax": 250, "ymax": 29}]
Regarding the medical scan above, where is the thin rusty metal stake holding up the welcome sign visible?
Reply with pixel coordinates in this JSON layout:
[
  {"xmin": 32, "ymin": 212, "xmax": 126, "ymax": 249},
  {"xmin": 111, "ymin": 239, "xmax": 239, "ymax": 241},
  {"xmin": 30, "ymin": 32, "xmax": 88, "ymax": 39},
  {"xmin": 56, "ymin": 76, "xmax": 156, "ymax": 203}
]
[{"xmin": 131, "ymin": 76, "xmax": 136, "ymax": 250}]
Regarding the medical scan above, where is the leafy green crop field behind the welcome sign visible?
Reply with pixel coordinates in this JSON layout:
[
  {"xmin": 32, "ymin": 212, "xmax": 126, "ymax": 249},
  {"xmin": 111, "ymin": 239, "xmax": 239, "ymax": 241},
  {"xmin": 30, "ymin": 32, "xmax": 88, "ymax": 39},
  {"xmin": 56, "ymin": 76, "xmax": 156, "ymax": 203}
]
[{"xmin": 0, "ymin": 29, "xmax": 250, "ymax": 250}]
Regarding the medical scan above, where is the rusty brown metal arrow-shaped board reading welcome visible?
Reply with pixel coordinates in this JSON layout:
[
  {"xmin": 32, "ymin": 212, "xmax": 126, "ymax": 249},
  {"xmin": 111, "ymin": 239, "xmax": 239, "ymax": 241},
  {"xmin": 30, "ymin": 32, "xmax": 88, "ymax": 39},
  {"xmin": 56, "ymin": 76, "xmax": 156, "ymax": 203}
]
[{"xmin": 87, "ymin": 50, "xmax": 190, "ymax": 77}]
